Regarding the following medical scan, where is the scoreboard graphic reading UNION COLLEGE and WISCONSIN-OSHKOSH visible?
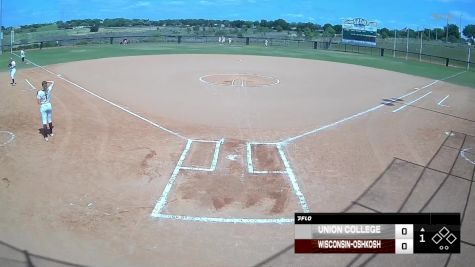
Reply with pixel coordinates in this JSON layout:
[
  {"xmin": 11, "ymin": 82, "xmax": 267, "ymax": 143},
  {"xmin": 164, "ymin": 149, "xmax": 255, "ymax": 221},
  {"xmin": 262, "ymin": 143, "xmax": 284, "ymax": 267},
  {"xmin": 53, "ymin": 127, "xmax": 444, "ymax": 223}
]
[{"xmin": 295, "ymin": 213, "xmax": 461, "ymax": 254}]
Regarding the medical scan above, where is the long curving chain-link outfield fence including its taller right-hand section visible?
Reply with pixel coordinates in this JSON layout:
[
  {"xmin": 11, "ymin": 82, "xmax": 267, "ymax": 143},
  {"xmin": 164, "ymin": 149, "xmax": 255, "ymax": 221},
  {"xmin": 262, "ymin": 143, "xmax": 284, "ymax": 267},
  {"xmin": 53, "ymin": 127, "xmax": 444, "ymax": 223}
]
[{"xmin": 3, "ymin": 32, "xmax": 473, "ymax": 72}]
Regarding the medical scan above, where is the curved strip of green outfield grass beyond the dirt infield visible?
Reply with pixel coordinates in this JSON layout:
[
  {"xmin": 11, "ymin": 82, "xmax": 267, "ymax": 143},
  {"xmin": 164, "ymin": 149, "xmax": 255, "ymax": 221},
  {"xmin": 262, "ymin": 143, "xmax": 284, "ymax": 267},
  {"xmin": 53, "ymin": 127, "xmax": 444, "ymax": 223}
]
[{"xmin": 0, "ymin": 43, "xmax": 475, "ymax": 88}]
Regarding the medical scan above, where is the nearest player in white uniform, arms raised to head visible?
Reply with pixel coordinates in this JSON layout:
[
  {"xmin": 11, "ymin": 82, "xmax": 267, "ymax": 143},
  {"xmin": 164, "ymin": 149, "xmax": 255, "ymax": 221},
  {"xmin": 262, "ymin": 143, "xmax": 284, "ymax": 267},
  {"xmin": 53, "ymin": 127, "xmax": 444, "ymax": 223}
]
[{"xmin": 36, "ymin": 81, "xmax": 54, "ymax": 142}]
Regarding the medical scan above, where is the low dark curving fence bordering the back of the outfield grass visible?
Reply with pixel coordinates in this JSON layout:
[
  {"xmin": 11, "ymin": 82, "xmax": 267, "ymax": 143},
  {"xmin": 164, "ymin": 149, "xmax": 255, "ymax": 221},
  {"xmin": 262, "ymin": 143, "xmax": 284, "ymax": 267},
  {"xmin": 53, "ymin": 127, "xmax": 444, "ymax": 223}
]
[{"xmin": 3, "ymin": 34, "xmax": 473, "ymax": 69}]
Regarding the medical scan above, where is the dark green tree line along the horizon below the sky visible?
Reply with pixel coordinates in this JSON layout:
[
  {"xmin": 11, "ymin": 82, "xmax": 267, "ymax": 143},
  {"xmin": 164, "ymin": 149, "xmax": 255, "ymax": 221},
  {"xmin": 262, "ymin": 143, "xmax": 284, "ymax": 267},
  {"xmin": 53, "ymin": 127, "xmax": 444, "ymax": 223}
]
[{"xmin": 2, "ymin": 18, "xmax": 475, "ymax": 42}]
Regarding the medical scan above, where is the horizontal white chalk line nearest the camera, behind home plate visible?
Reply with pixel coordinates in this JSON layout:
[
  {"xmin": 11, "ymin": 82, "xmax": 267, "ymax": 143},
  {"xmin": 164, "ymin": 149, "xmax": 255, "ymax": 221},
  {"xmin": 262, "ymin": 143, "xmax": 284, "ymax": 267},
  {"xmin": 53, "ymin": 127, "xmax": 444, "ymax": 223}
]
[{"xmin": 152, "ymin": 213, "xmax": 294, "ymax": 224}]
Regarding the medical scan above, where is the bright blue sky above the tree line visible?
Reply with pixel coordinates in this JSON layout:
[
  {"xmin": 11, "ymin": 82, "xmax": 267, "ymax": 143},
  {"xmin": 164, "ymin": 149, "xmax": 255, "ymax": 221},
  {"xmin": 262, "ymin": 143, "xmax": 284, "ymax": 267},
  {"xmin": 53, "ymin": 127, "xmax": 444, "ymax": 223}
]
[{"xmin": 1, "ymin": 0, "xmax": 475, "ymax": 29}]
